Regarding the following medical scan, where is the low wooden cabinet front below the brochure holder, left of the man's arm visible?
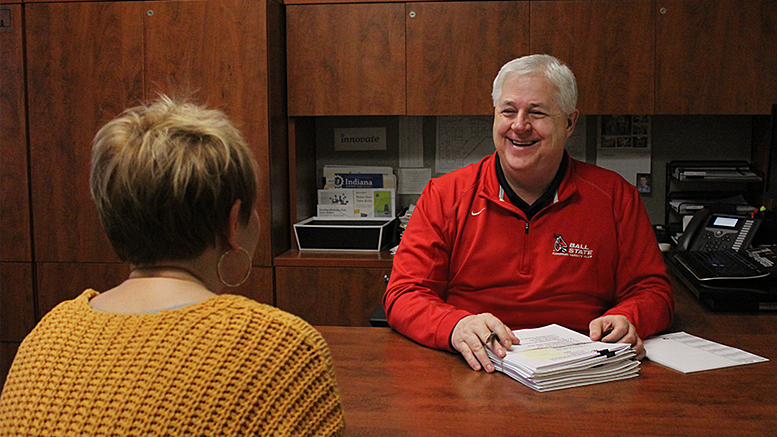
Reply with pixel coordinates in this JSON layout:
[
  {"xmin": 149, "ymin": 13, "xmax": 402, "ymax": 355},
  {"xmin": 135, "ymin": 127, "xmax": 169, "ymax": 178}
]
[{"xmin": 275, "ymin": 267, "xmax": 391, "ymax": 326}]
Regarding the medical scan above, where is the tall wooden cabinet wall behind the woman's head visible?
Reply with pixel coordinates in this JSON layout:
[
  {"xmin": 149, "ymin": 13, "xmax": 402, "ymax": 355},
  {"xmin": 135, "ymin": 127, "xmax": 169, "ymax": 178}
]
[{"xmin": 0, "ymin": 0, "xmax": 290, "ymax": 380}]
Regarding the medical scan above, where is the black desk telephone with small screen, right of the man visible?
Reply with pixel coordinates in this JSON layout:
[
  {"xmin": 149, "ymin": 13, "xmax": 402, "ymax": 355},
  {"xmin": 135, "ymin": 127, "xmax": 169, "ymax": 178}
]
[{"xmin": 674, "ymin": 209, "xmax": 777, "ymax": 281}]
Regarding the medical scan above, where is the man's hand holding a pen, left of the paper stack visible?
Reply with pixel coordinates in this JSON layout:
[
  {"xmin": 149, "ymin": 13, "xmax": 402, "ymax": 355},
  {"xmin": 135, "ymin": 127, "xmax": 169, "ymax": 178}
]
[{"xmin": 451, "ymin": 313, "xmax": 520, "ymax": 373}]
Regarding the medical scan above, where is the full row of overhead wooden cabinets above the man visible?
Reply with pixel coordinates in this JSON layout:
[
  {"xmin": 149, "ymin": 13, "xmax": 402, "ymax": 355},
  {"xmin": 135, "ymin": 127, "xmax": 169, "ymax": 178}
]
[{"xmin": 287, "ymin": 0, "xmax": 777, "ymax": 115}]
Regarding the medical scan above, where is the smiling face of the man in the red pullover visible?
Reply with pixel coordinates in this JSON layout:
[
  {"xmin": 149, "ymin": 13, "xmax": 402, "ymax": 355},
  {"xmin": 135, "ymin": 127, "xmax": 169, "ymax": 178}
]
[{"xmin": 493, "ymin": 75, "xmax": 578, "ymax": 195}]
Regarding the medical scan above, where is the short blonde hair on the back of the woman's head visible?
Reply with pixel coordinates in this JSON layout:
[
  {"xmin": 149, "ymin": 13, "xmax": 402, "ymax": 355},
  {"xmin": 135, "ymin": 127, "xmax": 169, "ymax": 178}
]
[{"xmin": 91, "ymin": 96, "xmax": 257, "ymax": 265}]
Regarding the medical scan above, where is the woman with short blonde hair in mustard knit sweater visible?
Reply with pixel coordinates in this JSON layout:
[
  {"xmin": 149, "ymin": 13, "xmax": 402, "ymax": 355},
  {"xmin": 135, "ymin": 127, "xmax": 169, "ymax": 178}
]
[{"xmin": 0, "ymin": 97, "xmax": 344, "ymax": 436}]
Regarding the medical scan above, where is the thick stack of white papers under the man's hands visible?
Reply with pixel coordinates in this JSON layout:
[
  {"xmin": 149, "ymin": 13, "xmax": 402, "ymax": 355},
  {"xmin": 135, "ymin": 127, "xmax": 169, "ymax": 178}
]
[{"xmin": 486, "ymin": 324, "xmax": 640, "ymax": 392}]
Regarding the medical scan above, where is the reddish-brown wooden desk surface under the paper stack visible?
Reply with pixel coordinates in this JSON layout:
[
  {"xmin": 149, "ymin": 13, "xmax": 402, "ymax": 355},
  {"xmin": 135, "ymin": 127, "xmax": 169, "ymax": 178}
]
[{"xmin": 318, "ymin": 274, "xmax": 777, "ymax": 437}]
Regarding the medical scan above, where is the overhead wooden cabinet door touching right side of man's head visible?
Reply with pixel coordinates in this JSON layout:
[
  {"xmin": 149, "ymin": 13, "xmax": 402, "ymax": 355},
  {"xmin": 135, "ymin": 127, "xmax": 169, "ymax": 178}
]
[{"xmin": 531, "ymin": 0, "xmax": 655, "ymax": 114}]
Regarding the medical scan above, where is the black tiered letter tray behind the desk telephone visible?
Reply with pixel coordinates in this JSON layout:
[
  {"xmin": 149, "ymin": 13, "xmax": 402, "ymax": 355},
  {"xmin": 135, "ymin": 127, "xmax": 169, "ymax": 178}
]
[{"xmin": 664, "ymin": 161, "xmax": 762, "ymax": 236}]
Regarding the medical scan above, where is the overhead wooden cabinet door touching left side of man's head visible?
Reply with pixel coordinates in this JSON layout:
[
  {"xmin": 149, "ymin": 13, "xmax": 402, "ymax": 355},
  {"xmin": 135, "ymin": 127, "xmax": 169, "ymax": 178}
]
[{"xmin": 406, "ymin": 1, "xmax": 529, "ymax": 115}]
